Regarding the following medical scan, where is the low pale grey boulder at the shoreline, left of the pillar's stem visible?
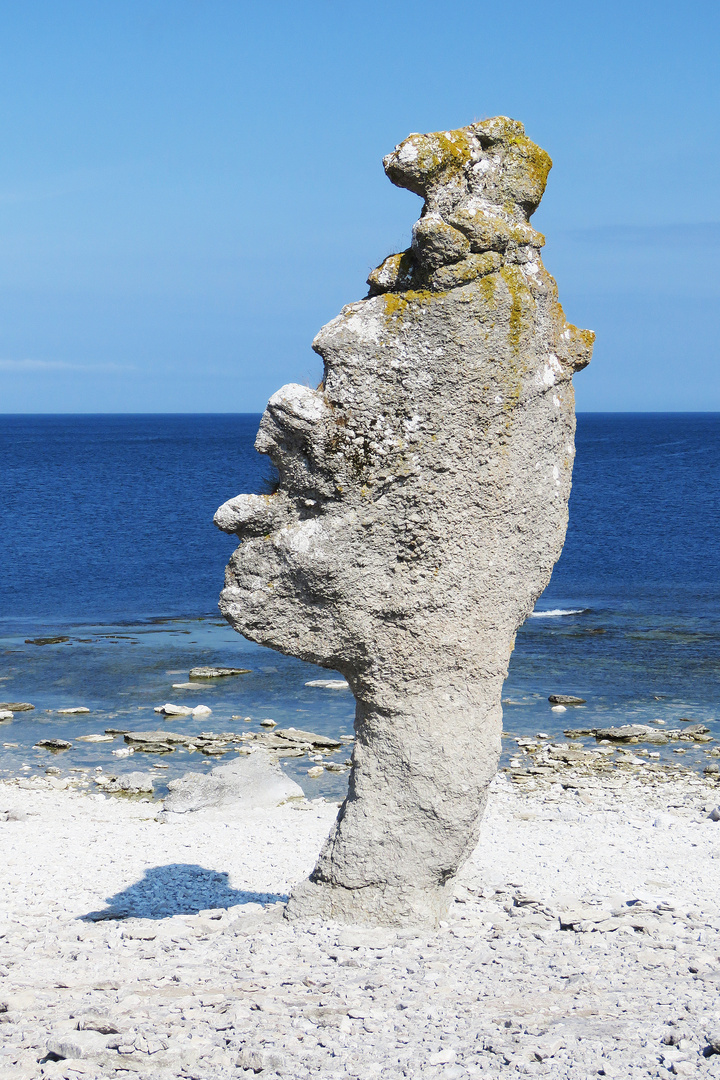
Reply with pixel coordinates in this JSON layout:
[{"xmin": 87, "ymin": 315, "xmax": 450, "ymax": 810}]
[{"xmin": 164, "ymin": 752, "xmax": 303, "ymax": 813}]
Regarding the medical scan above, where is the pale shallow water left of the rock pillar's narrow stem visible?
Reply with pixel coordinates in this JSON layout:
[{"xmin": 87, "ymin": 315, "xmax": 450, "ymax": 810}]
[{"xmin": 0, "ymin": 617, "xmax": 354, "ymax": 797}]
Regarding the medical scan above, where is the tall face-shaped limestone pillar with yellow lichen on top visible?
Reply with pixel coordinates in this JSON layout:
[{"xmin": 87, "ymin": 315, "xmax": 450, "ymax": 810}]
[{"xmin": 216, "ymin": 117, "xmax": 594, "ymax": 923}]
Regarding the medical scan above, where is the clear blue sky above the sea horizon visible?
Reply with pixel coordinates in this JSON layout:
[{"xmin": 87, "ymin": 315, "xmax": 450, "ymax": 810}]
[{"xmin": 0, "ymin": 0, "xmax": 720, "ymax": 413}]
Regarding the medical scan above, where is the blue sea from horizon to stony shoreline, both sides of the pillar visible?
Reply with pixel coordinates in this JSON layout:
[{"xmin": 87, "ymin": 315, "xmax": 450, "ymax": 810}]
[{"xmin": 0, "ymin": 413, "xmax": 720, "ymax": 797}]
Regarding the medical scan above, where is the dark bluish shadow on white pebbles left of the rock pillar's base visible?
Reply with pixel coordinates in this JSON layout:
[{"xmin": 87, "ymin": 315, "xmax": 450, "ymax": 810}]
[{"xmin": 80, "ymin": 863, "xmax": 287, "ymax": 922}]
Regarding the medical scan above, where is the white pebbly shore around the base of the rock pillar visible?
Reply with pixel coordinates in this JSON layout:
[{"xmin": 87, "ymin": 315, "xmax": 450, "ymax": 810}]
[{"xmin": 0, "ymin": 770, "xmax": 720, "ymax": 1080}]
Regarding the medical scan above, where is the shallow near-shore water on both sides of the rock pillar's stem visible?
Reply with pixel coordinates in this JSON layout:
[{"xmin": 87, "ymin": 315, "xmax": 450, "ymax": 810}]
[{"xmin": 0, "ymin": 610, "xmax": 720, "ymax": 798}]
